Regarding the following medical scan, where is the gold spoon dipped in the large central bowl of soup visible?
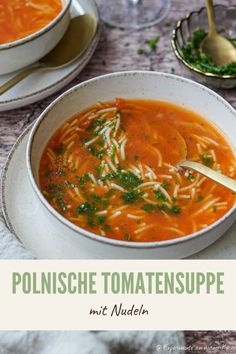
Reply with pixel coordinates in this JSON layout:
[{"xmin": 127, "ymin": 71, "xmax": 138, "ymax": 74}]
[{"xmin": 172, "ymin": 126, "xmax": 236, "ymax": 192}]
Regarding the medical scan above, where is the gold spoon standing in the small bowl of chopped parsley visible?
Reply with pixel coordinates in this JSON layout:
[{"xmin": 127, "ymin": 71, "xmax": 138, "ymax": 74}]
[{"xmin": 200, "ymin": 0, "xmax": 236, "ymax": 66}]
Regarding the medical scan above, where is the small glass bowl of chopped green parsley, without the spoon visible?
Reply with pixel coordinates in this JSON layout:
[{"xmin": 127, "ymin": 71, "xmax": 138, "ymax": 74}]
[{"xmin": 172, "ymin": 5, "xmax": 236, "ymax": 89}]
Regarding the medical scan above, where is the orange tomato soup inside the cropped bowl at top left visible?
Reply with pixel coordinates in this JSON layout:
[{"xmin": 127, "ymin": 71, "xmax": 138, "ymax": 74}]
[{"xmin": 0, "ymin": 0, "xmax": 62, "ymax": 44}]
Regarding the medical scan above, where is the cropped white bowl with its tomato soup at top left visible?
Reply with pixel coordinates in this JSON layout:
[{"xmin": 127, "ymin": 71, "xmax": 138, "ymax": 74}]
[{"xmin": 0, "ymin": 0, "xmax": 71, "ymax": 75}]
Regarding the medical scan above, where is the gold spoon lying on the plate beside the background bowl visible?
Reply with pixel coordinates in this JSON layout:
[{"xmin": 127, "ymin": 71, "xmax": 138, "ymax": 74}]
[{"xmin": 0, "ymin": 14, "xmax": 97, "ymax": 95}]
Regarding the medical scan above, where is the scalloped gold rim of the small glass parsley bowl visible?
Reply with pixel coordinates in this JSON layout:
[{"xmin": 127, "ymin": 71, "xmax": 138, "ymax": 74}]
[{"xmin": 171, "ymin": 5, "xmax": 236, "ymax": 80}]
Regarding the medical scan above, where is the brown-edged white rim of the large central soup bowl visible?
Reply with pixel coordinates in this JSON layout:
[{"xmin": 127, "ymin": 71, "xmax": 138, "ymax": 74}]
[{"xmin": 26, "ymin": 70, "xmax": 236, "ymax": 249}]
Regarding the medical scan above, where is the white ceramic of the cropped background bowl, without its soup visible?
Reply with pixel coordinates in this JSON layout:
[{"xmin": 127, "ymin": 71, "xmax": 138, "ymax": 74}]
[{"xmin": 0, "ymin": 0, "xmax": 72, "ymax": 75}]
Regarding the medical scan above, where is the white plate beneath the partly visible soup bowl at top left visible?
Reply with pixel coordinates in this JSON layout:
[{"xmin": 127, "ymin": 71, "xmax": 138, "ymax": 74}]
[{"xmin": 0, "ymin": 0, "xmax": 100, "ymax": 111}]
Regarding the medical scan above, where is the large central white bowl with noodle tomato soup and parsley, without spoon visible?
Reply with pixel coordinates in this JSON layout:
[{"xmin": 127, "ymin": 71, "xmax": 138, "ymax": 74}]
[{"xmin": 27, "ymin": 71, "xmax": 236, "ymax": 259}]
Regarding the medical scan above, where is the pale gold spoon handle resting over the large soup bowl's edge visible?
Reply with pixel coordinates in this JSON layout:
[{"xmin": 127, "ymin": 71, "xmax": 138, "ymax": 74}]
[{"xmin": 179, "ymin": 161, "xmax": 236, "ymax": 192}]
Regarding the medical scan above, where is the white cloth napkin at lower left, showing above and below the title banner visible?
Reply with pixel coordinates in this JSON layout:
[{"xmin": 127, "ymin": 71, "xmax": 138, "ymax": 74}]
[{"xmin": 0, "ymin": 217, "xmax": 185, "ymax": 354}]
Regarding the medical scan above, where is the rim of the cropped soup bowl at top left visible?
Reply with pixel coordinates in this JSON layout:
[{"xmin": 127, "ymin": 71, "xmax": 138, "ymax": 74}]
[{"xmin": 0, "ymin": 0, "xmax": 72, "ymax": 51}]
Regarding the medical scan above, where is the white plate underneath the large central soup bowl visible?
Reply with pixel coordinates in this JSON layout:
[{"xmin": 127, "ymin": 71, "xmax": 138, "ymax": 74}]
[{"xmin": 2, "ymin": 127, "xmax": 236, "ymax": 259}]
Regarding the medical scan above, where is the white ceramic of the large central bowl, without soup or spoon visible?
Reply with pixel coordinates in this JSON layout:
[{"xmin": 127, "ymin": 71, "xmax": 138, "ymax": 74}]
[{"xmin": 27, "ymin": 71, "xmax": 236, "ymax": 259}]
